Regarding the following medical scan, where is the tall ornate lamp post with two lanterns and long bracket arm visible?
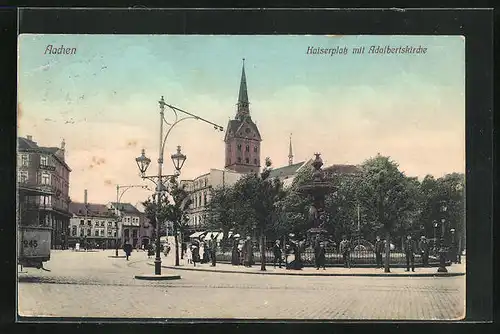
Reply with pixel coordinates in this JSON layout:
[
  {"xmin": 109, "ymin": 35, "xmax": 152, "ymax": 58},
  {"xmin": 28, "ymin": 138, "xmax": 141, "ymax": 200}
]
[{"xmin": 135, "ymin": 96, "xmax": 224, "ymax": 276}]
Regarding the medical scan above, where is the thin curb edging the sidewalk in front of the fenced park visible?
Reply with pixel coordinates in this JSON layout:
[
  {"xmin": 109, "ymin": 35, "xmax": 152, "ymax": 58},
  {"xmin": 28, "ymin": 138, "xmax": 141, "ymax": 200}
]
[{"xmin": 148, "ymin": 263, "xmax": 465, "ymax": 277}]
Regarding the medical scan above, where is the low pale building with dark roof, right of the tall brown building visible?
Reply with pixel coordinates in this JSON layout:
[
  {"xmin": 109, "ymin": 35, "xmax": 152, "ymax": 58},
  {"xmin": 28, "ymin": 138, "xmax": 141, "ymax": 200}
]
[{"xmin": 68, "ymin": 202, "xmax": 121, "ymax": 248}]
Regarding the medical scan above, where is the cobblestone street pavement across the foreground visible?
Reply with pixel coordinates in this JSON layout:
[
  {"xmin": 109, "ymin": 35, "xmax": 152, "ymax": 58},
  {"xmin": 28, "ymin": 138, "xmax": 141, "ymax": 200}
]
[{"xmin": 18, "ymin": 250, "xmax": 465, "ymax": 320}]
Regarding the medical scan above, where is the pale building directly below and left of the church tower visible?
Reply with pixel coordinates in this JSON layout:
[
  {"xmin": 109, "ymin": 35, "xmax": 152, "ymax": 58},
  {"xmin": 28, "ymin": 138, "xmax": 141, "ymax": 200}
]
[{"xmin": 181, "ymin": 169, "xmax": 244, "ymax": 231}]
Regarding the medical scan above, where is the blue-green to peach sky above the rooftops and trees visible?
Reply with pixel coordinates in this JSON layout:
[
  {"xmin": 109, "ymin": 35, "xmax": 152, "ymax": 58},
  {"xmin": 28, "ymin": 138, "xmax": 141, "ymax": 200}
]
[{"xmin": 18, "ymin": 35, "xmax": 465, "ymax": 204}]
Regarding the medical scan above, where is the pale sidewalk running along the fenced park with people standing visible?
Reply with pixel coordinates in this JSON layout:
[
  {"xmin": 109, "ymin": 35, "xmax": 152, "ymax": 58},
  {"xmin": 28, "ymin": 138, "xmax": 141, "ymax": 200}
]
[{"xmin": 148, "ymin": 253, "xmax": 465, "ymax": 277}]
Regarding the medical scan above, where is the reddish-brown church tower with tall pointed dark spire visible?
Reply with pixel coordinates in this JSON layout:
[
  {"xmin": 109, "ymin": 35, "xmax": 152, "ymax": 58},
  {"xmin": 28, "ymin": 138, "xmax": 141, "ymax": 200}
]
[{"xmin": 224, "ymin": 58, "xmax": 262, "ymax": 173}]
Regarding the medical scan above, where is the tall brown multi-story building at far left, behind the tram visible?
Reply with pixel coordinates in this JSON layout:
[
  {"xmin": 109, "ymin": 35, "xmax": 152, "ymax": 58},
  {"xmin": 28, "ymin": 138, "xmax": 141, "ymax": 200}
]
[{"xmin": 17, "ymin": 136, "xmax": 72, "ymax": 248}]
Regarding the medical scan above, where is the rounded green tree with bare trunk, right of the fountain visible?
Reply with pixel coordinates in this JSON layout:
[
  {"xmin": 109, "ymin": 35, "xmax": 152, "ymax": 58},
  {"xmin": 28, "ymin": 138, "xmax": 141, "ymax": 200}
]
[{"xmin": 357, "ymin": 154, "xmax": 415, "ymax": 272}]
